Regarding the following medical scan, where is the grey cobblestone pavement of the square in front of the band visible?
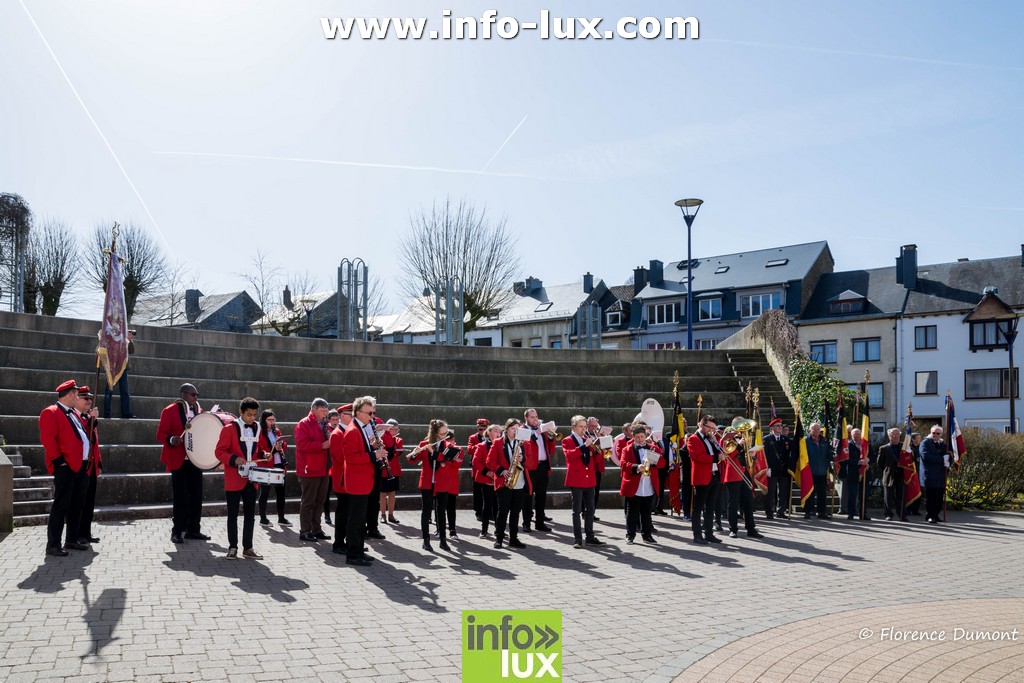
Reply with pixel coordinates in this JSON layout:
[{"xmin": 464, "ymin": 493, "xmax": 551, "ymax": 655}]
[{"xmin": 0, "ymin": 510, "xmax": 1024, "ymax": 683}]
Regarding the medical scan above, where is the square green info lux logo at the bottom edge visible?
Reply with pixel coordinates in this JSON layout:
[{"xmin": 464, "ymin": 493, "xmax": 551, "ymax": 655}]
[{"xmin": 462, "ymin": 609, "xmax": 562, "ymax": 683}]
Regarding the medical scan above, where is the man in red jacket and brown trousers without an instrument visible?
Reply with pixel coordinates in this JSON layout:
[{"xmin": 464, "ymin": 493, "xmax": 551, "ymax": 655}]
[{"xmin": 295, "ymin": 398, "xmax": 331, "ymax": 543}]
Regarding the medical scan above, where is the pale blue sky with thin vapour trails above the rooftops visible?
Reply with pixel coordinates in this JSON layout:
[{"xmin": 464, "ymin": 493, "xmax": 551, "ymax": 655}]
[{"xmin": 0, "ymin": 0, "xmax": 1024, "ymax": 317}]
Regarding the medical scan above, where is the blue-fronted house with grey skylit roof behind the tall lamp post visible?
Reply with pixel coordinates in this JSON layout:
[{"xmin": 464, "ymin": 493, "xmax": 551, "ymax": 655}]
[{"xmin": 629, "ymin": 242, "xmax": 835, "ymax": 349}]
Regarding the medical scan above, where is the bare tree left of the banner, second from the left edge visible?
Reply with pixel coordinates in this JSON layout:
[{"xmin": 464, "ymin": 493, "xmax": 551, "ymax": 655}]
[{"xmin": 26, "ymin": 218, "xmax": 80, "ymax": 315}]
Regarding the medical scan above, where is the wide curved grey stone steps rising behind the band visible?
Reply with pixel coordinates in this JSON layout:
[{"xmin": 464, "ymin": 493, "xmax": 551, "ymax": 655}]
[{"xmin": 0, "ymin": 312, "xmax": 793, "ymax": 525}]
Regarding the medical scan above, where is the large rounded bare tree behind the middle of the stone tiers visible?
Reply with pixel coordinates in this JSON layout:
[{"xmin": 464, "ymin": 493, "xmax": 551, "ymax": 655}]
[{"xmin": 398, "ymin": 198, "xmax": 520, "ymax": 332}]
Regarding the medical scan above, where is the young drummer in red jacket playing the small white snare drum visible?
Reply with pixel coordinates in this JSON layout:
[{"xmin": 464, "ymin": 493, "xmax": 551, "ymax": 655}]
[{"xmin": 214, "ymin": 396, "xmax": 273, "ymax": 560}]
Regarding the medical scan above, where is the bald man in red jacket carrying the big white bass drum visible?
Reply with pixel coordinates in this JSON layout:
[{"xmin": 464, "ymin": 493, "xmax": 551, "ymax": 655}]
[{"xmin": 157, "ymin": 382, "xmax": 210, "ymax": 543}]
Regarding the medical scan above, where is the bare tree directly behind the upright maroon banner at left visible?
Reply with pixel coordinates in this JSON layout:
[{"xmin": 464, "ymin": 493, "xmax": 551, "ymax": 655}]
[{"xmin": 86, "ymin": 222, "xmax": 167, "ymax": 318}]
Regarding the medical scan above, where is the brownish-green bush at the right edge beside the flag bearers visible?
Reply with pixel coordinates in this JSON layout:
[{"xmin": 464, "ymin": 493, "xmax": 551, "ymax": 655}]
[{"xmin": 946, "ymin": 429, "xmax": 1024, "ymax": 509}]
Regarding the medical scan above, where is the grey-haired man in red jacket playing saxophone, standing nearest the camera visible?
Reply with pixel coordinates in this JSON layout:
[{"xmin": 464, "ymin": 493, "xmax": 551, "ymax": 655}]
[{"xmin": 341, "ymin": 396, "xmax": 385, "ymax": 566}]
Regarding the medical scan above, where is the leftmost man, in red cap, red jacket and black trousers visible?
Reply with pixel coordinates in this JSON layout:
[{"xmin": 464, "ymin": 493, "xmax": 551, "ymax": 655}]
[{"xmin": 39, "ymin": 380, "xmax": 89, "ymax": 557}]
